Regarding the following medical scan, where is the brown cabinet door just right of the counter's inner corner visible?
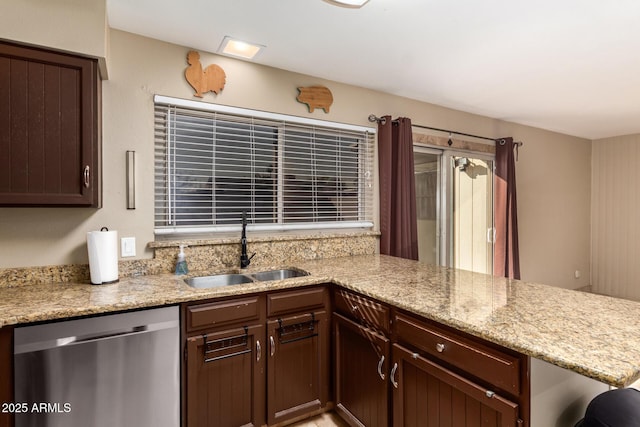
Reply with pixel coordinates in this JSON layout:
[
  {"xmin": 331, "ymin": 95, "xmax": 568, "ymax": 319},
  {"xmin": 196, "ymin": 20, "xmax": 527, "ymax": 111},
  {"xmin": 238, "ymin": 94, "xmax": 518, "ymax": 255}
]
[{"xmin": 333, "ymin": 313, "xmax": 390, "ymax": 427}]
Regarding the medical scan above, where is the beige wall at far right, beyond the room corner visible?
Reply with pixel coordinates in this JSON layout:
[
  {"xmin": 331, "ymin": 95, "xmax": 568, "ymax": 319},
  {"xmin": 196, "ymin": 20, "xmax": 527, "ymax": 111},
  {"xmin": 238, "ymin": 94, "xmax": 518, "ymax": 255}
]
[{"xmin": 591, "ymin": 135, "xmax": 640, "ymax": 300}]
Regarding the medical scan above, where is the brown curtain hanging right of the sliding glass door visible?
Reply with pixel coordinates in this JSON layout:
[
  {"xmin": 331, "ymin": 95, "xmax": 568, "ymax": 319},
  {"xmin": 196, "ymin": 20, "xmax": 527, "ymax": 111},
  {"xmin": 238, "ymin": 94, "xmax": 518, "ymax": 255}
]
[{"xmin": 493, "ymin": 138, "xmax": 520, "ymax": 279}]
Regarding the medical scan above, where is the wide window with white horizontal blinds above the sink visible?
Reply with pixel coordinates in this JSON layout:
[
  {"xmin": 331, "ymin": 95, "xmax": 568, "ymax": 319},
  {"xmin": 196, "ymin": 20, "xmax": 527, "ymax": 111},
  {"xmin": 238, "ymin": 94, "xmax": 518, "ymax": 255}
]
[{"xmin": 155, "ymin": 96, "xmax": 375, "ymax": 234}]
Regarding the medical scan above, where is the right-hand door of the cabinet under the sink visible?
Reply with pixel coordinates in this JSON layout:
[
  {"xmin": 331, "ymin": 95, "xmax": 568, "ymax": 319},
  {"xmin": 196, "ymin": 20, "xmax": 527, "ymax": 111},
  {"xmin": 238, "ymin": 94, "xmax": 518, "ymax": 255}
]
[{"xmin": 267, "ymin": 311, "xmax": 329, "ymax": 425}]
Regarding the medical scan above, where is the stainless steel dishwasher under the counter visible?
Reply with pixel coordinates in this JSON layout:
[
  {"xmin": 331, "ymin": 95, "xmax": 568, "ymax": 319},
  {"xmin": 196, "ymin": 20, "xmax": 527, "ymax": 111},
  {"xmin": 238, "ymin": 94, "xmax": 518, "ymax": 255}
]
[{"xmin": 14, "ymin": 307, "xmax": 180, "ymax": 427}]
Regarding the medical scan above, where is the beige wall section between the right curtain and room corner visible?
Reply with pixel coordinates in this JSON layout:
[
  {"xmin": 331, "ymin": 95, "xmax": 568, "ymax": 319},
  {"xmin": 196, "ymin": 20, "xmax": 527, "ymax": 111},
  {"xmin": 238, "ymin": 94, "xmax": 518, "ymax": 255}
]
[{"xmin": 502, "ymin": 125, "xmax": 591, "ymax": 289}]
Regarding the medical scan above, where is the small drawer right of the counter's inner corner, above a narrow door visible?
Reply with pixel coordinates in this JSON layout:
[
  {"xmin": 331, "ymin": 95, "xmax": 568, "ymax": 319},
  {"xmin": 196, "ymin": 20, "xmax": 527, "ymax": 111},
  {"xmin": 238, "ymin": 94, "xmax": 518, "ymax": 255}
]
[{"xmin": 335, "ymin": 289, "xmax": 391, "ymax": 333}]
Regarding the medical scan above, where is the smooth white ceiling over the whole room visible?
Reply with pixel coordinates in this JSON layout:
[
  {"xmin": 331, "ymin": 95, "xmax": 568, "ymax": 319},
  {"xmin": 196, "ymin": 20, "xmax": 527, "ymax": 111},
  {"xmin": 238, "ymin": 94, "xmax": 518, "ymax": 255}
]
[{"xmin": 107, "ymin": 0, "xmax": 640, "ymax": 139}]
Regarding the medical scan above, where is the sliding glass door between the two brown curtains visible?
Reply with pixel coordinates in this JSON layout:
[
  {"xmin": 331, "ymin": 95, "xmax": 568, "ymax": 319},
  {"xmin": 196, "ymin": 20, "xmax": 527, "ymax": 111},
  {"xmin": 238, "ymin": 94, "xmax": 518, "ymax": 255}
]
[{"xmin": 414, "ymin": 146, "xmax": 494, "ymax": 274}]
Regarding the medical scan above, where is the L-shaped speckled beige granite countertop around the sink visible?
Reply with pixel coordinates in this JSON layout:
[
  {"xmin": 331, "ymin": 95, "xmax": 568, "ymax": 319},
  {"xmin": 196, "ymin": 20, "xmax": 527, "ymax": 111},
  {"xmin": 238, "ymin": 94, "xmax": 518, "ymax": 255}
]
[{"xmin": 0, "ymin": 255, "xmax": 640, "ymax": 387}]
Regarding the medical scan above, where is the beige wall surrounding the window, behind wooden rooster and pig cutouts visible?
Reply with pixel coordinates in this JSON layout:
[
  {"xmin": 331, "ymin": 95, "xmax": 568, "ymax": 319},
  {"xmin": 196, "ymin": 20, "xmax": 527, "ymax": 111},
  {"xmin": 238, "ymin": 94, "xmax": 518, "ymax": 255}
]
[{"xmin": 0, "ymin": 27, "xmax": 590, "ymax": 288}]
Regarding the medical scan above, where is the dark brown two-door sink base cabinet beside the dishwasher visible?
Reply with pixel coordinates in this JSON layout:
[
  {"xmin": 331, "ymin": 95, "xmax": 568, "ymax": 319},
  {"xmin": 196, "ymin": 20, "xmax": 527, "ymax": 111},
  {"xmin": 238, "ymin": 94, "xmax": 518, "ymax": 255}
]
[{"xmin": 182, "ymin": 286, "xmax": 330, "ymax": 427}]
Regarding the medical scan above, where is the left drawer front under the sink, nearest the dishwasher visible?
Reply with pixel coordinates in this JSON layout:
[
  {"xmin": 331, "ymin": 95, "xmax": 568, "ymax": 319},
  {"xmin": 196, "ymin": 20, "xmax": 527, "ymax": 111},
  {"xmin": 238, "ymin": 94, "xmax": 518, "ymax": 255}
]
[{"xmin": 186, "ymin": 296, "xmax": 264, "ymax": 331}]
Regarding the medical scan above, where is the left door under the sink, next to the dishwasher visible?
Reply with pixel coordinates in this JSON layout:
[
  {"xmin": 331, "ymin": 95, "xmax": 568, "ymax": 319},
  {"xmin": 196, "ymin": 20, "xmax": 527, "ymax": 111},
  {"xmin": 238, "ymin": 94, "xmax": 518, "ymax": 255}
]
[{"xmin": 185, "ymin": 324, "xmax": 266, "ymax": 427}]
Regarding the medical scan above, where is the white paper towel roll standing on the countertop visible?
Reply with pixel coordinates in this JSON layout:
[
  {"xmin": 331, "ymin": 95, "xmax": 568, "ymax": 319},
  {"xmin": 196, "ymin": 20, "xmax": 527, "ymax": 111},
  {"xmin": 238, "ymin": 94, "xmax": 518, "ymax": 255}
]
[{"xmin": 87, "ymin": 227, "xmax": 118, "ymax": 285}]
